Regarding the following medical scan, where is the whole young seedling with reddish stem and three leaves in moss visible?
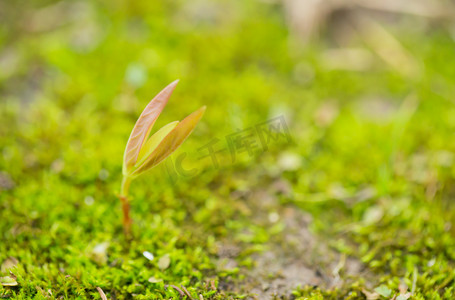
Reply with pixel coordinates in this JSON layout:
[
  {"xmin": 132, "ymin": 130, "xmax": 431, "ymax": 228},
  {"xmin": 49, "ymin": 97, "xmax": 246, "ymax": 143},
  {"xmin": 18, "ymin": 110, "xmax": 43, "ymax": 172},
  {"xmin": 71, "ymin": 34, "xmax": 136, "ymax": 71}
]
[{"xmin": 120, "ymin": 80, "xmax": 205, "ymax": 238}]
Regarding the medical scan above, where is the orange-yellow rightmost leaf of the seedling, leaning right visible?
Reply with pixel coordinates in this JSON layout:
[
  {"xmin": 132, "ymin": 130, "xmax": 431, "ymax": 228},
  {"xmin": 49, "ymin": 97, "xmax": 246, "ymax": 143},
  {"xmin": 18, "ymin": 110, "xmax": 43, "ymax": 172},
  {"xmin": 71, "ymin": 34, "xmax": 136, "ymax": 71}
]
[{"xmin": 132, "ymin": 106, "xmax": 205, "ymax": 176}]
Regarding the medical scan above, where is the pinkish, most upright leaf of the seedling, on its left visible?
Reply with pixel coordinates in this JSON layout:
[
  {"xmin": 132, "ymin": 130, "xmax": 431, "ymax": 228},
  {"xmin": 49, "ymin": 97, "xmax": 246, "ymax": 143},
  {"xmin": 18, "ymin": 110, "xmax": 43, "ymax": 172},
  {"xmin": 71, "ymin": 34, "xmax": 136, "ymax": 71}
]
[{"xmin": 123, "ymin": 80, "xmax": 178, "ymax": 175}]
